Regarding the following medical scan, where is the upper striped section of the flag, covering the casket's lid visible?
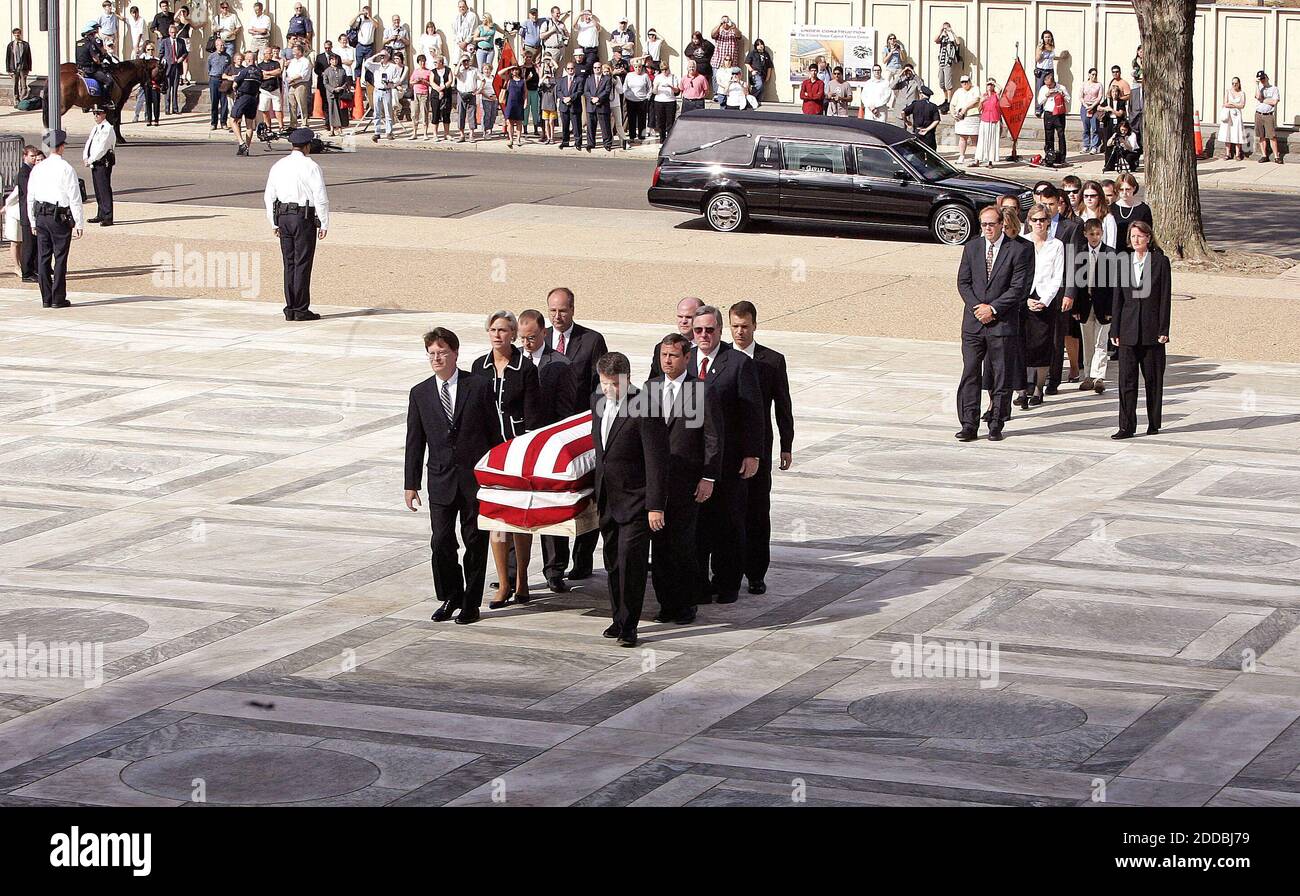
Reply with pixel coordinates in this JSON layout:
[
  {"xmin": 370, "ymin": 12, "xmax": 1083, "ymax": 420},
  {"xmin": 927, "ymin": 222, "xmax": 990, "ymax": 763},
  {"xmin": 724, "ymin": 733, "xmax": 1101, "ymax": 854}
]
[{"xmin": 475, "ymin": 411, "xmax": 595, "ymax": 492}]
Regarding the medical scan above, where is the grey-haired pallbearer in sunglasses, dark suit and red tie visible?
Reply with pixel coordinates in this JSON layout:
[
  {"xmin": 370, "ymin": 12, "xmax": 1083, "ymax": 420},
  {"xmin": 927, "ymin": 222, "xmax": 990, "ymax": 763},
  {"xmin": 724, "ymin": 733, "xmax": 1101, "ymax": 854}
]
[{"xmin": 690, "ymin": 304, "xmax": 763, "ymax": 603}]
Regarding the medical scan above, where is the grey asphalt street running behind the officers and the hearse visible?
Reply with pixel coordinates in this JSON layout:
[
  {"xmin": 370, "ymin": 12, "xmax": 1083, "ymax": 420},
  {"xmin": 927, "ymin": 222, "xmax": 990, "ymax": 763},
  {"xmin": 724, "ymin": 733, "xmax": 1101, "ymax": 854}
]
[{"xmin": 22, "ymin": 135, "xmax": 1300, "ymax": 260}]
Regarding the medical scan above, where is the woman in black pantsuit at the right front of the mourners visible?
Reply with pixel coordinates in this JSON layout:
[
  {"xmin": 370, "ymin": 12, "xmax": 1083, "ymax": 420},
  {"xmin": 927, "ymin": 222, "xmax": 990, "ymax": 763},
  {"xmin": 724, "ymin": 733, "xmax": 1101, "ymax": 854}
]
[{"xmin": 1110, "ymin": 221, "xmax": 1173, "ymax": 438}]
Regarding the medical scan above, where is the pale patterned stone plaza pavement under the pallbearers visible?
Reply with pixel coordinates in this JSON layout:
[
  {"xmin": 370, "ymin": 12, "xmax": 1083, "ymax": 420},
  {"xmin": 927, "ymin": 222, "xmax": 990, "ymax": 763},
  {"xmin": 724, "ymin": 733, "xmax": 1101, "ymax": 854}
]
[{"xmin": 0, "ymin": 290, "xmax": 1300, "ymax": 806}]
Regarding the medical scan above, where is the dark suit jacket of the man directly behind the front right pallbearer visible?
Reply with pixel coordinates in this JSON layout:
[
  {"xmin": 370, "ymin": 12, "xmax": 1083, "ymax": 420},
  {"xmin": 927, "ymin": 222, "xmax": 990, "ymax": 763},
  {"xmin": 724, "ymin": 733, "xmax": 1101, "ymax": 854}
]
[{"xmin": 642, "ymin": 371, "xmax": 723, "ymax": 503}]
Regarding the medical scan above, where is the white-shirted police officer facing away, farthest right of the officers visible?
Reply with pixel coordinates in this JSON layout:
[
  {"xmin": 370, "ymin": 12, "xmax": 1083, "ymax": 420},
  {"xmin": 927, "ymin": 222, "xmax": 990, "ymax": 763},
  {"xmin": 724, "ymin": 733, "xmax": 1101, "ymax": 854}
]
[{"xmin": 263, "ymin": 127, "xmax": 329, "ymax": 320}]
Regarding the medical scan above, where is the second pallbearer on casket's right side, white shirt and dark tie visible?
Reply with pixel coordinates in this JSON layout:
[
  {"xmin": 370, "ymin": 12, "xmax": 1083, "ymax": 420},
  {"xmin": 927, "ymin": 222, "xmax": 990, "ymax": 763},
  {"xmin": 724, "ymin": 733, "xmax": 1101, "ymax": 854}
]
[{"xmin": 645, "ymin": 333, "xmax": 723, "ymax": 626}]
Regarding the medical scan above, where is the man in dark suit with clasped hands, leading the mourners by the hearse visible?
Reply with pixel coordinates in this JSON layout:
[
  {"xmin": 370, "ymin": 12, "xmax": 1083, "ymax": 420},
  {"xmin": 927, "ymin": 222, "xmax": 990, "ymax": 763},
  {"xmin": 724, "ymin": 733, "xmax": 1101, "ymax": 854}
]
[{"xmin": 957, "ymin": 205, "xmax": 1034, "ymax": 442}]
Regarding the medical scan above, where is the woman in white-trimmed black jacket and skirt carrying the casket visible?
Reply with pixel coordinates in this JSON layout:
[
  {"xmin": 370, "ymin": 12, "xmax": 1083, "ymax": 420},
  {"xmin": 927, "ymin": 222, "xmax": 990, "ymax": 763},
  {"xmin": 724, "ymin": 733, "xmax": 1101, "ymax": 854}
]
[{"xmin": 471, "ymin": 311, "xmax": 543, "ymax": 610}]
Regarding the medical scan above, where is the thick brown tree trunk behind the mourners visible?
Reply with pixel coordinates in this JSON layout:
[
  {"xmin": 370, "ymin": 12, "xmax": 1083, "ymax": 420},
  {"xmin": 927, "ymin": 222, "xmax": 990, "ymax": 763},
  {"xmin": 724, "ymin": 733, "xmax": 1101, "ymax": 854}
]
[{"xmin": 1134, "ymin": 0, "xmax": 1214, "ymax": 261}]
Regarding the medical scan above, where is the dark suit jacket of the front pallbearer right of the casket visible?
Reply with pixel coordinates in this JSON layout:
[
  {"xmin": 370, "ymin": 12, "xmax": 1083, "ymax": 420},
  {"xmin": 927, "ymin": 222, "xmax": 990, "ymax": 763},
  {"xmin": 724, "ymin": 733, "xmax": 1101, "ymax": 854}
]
[{"xmin": 592, "ymin": 389, "xmax": 668, "ymax": 525}]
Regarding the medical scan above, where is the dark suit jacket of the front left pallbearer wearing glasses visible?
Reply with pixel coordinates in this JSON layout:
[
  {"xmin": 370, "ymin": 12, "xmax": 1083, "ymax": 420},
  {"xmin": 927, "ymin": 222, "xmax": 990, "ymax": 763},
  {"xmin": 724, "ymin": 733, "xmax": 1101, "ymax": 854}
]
[{"xmin": 406, "ymin": 371, "xmax": 502, "ymax": 505}]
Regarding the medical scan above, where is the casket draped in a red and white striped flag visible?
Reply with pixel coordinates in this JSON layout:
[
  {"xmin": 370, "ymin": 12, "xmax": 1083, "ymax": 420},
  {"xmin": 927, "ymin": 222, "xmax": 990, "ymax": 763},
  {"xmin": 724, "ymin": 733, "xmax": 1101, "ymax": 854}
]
[{"xmin": 475, "ymin": 411, "xmax": 597, "ymax": 537}]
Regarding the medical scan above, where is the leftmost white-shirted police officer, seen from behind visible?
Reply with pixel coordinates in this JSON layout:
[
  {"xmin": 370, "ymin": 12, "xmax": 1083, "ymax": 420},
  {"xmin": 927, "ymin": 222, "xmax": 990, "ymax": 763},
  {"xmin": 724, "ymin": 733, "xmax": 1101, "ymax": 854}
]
[{"xmin": 27, "ymin": 130, "xmax": 86, "ymax": 308}]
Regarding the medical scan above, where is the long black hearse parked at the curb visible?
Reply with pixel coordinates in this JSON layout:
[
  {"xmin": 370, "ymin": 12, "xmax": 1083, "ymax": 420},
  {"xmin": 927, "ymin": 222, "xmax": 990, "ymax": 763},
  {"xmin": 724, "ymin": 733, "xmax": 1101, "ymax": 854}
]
[{"xmin": 647, "ymin": 109, "xmax": 1032, "ymax": 246}]
